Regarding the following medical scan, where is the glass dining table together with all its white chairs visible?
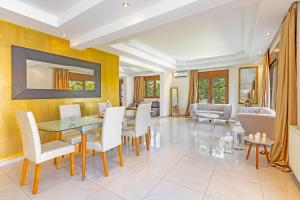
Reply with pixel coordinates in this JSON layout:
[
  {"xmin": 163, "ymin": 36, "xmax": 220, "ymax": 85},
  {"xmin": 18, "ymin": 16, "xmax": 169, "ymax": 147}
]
[{"xmin": 16, "ymin": 103, "xmax": 151, "ymax": 195}]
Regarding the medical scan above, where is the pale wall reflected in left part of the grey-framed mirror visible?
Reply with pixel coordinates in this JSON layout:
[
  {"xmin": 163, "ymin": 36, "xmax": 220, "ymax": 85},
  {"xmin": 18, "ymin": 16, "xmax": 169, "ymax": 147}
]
[{"xmin": 27, "ymin": 65, "xmax": 53, "ymax": 89}]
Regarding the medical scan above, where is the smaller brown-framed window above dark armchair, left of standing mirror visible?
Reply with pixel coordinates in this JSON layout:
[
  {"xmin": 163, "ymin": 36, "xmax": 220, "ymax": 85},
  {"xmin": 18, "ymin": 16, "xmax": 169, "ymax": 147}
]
[{"xmin": 144, "ymin": 76, "xmax": 160, "ymax": 98}]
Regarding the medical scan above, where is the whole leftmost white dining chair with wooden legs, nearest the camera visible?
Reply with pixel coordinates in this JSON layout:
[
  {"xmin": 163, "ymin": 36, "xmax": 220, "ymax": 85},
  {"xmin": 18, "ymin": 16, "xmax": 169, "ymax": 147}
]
[{"xmin": 17, "ymin": 111, "xmax": 75, "ymax": 194}]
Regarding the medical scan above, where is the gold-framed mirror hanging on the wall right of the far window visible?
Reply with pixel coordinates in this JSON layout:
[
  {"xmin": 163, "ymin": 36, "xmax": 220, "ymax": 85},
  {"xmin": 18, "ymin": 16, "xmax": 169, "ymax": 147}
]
[{"xmin": 239, "ymin": 66, "xmax": 258, "ymax": 104}]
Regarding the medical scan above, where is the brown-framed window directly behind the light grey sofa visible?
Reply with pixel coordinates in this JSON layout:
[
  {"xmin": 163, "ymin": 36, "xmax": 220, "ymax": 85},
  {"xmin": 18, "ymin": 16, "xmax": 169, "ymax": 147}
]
[{"xmin": 198, "ymin": 70, "xmax": 228, "ymax": 104}]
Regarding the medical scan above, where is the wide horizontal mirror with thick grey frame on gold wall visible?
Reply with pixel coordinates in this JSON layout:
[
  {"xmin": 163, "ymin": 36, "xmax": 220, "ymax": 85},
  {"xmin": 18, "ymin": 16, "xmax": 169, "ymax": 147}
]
[{"xmin": 12, "ymin": 46, "xmax": 101, "ymax": 99}]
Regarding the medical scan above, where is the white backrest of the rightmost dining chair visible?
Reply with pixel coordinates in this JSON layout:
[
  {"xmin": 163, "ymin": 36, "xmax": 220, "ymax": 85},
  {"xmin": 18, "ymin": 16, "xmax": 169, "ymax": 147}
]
[{"xmin": 135, "ymin": 104, "xmax": 151, "ymax": 137}]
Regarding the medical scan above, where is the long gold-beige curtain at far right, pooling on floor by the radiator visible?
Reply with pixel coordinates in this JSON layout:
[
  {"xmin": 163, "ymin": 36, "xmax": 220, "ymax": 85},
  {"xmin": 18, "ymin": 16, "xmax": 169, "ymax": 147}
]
[{"xmin": 271, "ymin": 3, "xmax": 297, "ymax": 171}]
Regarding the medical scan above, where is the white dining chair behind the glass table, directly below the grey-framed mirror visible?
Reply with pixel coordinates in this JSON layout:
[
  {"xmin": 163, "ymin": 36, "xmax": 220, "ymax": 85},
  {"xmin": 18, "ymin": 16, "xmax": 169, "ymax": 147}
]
[{"xmin": 59, "ymin": 104, "xmax": 94, "ymax": 145}]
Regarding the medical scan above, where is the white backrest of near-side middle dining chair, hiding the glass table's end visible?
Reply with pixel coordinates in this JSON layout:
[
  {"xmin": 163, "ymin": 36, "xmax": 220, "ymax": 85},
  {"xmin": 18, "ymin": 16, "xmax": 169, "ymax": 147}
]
[{"xmin": 101, "ymin": 107, "xmax": 125, "ymax": 151}]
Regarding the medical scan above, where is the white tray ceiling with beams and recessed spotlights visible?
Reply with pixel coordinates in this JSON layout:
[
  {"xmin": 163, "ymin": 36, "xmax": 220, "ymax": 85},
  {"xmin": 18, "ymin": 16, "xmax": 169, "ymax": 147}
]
[{"xmin": 0, "ymin": 0, "xmax": 293, "ymax": 75}]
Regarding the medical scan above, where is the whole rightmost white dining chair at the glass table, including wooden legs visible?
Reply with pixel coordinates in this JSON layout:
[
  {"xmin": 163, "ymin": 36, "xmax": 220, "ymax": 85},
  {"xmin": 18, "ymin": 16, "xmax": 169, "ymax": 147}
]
[{"xmin": 122, "ymin": 104, "xmax": 151, "ymax": 156}]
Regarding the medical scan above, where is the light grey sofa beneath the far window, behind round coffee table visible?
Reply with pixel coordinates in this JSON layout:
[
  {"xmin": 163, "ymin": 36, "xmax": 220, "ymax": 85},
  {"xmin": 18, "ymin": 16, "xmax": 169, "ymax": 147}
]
[{"xmin": 190, "ymin": 103, "xmax": 232, "ymax": 122}]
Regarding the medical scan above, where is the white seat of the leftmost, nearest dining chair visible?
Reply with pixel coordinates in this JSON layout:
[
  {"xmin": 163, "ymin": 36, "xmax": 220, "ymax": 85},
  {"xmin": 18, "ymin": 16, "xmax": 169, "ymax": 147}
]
[{"xmin": 41, "ymin": 140, "xmax": 75, "ymax": 162}]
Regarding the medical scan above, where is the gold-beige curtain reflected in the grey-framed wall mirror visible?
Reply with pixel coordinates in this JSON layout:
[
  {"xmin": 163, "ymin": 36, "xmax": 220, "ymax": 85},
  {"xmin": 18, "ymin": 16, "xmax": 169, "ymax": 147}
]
[{"xmin": 53, "ymin": 68, "xmax": 70, "ymax": 90}]
